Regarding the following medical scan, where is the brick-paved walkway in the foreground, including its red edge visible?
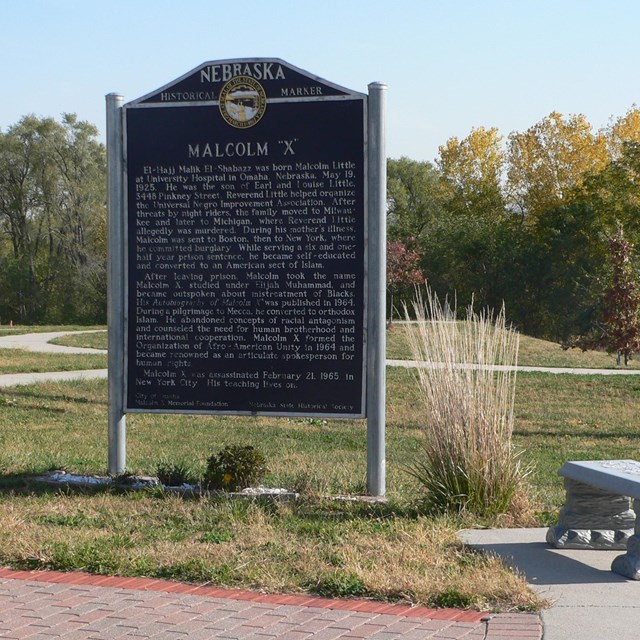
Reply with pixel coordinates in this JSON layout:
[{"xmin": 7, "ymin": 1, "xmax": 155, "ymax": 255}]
[{"xmin": 0, "ymin": 569, "xmax": 541, "ymax": 640}]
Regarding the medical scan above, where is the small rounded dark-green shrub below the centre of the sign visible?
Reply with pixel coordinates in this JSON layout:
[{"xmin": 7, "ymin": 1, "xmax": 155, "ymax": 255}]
[{"xmin": 204, "ymin": 445, "xmax": 267, "ymax": 491}]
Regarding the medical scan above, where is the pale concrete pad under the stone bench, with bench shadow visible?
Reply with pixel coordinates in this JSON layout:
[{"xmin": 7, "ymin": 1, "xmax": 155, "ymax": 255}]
[{"xmin": 460, "ymin": 529, "xmax": 640, "ymax": 640}]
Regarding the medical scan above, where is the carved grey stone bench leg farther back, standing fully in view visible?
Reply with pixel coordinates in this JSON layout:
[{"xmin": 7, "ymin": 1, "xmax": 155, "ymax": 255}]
[{"xmin": 547, "ymin": 478, "xmax": 640, "ymax": 549}]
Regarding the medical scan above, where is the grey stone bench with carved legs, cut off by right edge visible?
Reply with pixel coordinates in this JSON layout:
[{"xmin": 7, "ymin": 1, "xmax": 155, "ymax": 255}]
[{"xmin": 547, "ymin": 460, "xmax": 640, "ymax": 580}]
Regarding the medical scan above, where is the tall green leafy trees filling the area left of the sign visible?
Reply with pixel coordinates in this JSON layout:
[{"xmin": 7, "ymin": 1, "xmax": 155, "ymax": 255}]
[{"xmin": 0, "ymin": 114, "xmax": 106, "ymax": 322}]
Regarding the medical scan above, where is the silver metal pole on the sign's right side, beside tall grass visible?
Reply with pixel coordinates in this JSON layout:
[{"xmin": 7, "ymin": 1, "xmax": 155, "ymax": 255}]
[{"xmin": 367, "ymin": 82, "xmax": 387, "ymax": 496}]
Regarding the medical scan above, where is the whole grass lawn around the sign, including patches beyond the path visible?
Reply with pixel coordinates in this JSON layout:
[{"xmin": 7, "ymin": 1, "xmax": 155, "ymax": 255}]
[{"xmin": 0, "ymin": 328, "xmax": 640, "ymax": 610}]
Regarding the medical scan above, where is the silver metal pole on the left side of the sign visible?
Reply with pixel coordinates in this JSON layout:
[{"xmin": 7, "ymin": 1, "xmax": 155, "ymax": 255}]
[{"xmin": 106, "ymin": 93, "xmax": 127, "ymax": 475}]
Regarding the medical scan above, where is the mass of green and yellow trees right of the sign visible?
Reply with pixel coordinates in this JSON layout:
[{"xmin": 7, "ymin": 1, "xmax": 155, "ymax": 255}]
[{"xmin": 389, "ymin": 107, "xmax": 640, "ymax": 344}]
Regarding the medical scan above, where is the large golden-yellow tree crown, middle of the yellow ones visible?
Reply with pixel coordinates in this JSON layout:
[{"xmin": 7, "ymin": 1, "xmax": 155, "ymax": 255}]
[{"xmin": 507, "ymin": 111, "xmax": 609, "ymax": 222}]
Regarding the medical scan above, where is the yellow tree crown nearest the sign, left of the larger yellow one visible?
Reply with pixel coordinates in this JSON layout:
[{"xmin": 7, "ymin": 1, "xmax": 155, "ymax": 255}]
[{"xmin": 437, "ymin": 127, "xmax": 505, "ymax": 218}]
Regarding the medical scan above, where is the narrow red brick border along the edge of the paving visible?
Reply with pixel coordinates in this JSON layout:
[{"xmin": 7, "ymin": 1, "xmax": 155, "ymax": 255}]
[{"xmin": 0, "ymin": 568, "xmax": 487, "ymax": 623}]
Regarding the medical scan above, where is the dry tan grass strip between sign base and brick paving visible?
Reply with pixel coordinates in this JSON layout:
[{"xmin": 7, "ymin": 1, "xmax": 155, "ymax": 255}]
[{"xmin": 0, "ymin": 494, "xmax": 540, "ymax": 610}]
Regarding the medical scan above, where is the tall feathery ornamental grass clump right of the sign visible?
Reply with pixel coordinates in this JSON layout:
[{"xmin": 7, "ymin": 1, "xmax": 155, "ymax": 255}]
[{"xmin": 405, "ymin": 289, "xmax": 526, "ymax": 516}]
